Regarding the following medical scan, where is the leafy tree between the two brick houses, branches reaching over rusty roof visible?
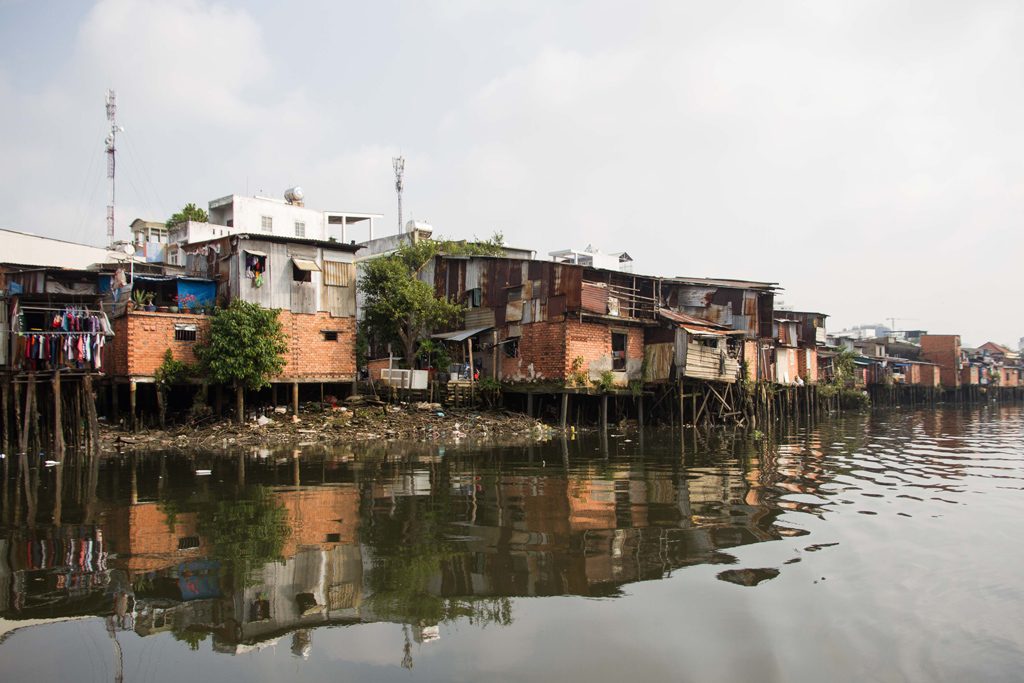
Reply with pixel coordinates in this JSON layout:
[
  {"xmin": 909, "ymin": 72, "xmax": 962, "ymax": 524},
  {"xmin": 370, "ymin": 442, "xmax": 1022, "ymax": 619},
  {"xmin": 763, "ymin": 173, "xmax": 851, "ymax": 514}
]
[{"xmin": 359, "ymin": 232, "xmax": 505, "ymax": 364}]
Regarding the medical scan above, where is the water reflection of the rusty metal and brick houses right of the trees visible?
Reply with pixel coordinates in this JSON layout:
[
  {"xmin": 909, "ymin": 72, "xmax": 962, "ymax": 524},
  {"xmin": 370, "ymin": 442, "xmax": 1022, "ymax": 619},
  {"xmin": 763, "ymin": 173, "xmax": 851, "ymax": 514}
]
[{"xmin": 364, "ymin": 468, "xmax": 780, "ymax": 597}]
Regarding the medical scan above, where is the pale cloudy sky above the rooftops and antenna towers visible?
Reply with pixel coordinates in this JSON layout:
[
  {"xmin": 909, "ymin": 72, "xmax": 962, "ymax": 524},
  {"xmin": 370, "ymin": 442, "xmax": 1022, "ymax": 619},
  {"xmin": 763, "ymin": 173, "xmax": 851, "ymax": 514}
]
[{"xmin": 0, "ymin": 0, "xmax": 1024, "ymax": 347}]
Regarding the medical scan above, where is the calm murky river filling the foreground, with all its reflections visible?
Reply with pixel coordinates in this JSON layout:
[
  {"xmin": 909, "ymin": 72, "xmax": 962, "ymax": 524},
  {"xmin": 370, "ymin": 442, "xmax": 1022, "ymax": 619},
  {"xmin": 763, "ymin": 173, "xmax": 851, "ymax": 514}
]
[{"xmin": 0, "ymin": 407, "xmax": 1024, "ymax": 682}]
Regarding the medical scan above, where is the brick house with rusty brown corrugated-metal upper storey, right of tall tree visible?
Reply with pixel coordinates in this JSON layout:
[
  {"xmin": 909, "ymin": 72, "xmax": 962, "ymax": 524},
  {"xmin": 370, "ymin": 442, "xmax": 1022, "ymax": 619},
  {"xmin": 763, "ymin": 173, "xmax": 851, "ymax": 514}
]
[{"xmin": 425, "ymin": 256, "xmax": 657, "ymax": 386}]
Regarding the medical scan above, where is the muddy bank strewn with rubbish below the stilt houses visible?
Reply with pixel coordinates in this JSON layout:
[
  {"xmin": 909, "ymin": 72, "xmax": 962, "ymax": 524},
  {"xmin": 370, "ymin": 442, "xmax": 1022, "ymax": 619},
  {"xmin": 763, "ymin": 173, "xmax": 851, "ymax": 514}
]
[{"xmin": 100, "ymin": 402, "xmax": 558, "ymax": 454}]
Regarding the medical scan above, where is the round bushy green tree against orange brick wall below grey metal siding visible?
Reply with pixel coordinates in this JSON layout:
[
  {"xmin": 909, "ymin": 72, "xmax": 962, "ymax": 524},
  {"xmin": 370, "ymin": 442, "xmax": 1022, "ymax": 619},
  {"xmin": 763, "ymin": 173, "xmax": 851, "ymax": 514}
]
[{"xmin": 196, "ymin": 299, "xmax": 288, "ymax": 422}]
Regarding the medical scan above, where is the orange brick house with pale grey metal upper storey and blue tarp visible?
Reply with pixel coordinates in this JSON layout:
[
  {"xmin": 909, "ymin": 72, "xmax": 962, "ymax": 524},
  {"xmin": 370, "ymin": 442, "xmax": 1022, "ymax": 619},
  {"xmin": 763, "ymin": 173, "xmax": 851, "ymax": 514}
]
[{"xmin": 109, "ymin": 233, "xmax": 357, "ymax": 393}]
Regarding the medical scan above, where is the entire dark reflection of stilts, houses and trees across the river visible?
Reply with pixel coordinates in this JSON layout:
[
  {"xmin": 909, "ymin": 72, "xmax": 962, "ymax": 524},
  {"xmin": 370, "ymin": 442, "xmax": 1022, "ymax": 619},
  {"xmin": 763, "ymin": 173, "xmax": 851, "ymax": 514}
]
[{"xmin": 0, "ymin": 405, "xmax": 1019, "ymax": 666}]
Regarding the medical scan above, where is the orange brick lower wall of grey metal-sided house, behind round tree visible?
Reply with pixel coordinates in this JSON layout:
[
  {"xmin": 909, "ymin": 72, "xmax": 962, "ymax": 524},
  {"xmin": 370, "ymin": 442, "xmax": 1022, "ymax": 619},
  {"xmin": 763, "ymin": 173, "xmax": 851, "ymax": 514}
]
[{"xmin": 111, "ymin": 310, "xmax": 355, "ymax": 381}]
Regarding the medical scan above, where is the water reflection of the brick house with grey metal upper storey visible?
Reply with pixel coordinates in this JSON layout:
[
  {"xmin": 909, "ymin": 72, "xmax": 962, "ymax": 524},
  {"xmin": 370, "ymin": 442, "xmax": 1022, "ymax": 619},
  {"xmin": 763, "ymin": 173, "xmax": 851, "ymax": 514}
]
[{"xmin": 122, "ymin": 484, "xmax": 362, "ymax": 654}]
